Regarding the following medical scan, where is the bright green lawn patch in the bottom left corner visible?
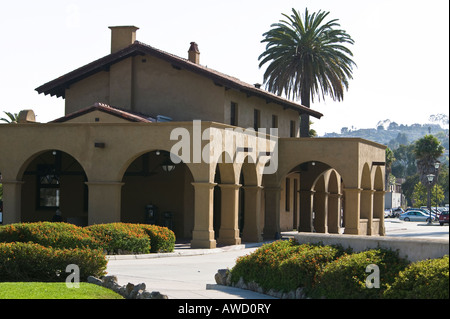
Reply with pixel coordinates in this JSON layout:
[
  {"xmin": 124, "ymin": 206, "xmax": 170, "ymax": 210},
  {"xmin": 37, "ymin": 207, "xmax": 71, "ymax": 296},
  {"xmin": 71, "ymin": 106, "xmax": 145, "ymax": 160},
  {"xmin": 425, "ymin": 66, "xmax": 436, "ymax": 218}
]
[{"xmin": 0, "ymin": 282, "xmax": 123, "ymax": 299}]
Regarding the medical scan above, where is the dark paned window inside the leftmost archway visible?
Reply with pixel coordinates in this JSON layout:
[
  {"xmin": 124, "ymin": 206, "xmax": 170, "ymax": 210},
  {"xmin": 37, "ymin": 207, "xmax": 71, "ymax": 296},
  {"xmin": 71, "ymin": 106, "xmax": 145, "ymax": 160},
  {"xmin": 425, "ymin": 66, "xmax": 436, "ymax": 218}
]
[{"xmin": 37, "ymin": 165, "xmax": 60, "ymax": 208}]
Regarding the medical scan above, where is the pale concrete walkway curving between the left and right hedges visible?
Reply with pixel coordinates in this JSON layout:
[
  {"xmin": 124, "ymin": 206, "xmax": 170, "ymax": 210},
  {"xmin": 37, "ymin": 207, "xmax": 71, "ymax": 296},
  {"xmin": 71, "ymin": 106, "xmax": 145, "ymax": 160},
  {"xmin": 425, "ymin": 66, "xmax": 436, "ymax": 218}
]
[{"xmin": 107, "ymin": 243, "xmax": 276, "ymax": 299}]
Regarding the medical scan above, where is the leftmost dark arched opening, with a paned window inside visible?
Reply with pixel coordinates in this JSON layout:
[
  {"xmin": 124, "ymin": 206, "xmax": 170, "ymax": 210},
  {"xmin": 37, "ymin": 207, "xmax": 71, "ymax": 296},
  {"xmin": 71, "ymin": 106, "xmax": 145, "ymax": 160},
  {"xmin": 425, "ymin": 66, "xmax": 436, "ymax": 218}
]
[{"xmin": 21, "ymin": 150, "xmax": 88, "ymax": 226}]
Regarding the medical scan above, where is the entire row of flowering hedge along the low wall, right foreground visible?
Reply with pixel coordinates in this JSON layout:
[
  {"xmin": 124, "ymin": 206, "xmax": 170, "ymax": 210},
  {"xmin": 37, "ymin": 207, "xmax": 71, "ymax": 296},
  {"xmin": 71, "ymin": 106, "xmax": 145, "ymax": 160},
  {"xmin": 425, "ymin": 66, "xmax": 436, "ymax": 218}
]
[{"xmin": 230, "ymin": 240, "xmax": 449, "ymax": 299}]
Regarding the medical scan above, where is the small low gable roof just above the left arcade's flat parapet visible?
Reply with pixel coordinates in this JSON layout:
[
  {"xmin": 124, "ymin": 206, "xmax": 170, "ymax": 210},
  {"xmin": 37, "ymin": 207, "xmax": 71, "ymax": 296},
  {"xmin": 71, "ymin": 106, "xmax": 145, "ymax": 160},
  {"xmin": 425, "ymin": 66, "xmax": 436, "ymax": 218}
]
[{"xmin": 49, "ymin": 103, "xmax": 156, "ymax": 123}]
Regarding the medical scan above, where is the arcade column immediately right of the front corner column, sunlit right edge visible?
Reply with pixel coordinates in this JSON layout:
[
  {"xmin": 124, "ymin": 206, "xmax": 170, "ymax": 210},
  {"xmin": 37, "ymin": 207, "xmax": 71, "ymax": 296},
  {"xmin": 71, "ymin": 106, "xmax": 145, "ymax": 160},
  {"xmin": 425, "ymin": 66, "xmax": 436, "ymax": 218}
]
[{"xmin": 217, "ymin": 184, "xmax": 241, "ymax": 245}]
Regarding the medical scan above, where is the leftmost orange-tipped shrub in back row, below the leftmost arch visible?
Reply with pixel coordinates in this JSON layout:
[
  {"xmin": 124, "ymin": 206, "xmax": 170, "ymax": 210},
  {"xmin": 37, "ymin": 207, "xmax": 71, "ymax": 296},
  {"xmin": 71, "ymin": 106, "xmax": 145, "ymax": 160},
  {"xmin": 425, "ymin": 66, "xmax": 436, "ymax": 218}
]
[{"xmin": 0, "ymin": 222, "xmax": 100, "ymax": 249}]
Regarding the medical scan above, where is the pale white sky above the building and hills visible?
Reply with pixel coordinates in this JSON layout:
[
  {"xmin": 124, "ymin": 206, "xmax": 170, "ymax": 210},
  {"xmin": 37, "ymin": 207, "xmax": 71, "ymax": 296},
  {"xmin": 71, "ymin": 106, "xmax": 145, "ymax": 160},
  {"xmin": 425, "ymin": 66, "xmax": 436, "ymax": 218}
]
[{"xmin": 0, "ymin": 0, "xmax": 449, "ymax": 136}]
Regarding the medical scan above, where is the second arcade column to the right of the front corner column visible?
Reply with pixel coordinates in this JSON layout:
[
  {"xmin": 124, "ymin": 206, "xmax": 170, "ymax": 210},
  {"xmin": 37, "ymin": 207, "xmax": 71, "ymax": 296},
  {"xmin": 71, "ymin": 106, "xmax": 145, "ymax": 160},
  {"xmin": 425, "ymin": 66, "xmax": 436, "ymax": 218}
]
[{"xmin": 242, "ymin": 186, "xmax": 262, "ymax": 242}]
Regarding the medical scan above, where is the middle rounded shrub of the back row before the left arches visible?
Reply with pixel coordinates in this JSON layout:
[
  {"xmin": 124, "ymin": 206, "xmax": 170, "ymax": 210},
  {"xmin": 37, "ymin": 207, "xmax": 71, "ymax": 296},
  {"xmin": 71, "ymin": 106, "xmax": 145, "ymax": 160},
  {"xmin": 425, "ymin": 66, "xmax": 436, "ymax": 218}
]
[{"xmin": 85, "ymin": 223, "xmax": 151, "ymax": 254}]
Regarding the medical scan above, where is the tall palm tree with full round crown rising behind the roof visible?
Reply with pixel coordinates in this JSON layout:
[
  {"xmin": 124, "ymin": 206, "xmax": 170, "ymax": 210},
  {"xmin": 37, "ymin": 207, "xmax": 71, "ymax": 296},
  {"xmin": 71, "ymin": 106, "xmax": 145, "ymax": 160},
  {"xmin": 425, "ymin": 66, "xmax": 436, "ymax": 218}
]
[{"xmin": 258, "ymin": 9, "xmax": 356, "ymax": 137}]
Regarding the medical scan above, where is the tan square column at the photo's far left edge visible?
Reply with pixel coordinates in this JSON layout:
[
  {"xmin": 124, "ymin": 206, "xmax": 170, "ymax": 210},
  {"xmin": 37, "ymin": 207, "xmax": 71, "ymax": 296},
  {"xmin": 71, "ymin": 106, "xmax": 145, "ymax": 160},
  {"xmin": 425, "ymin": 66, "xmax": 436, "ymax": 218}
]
[{"xmin": 2, "ymin": 181, "xmax": 24, "ymax": 225}]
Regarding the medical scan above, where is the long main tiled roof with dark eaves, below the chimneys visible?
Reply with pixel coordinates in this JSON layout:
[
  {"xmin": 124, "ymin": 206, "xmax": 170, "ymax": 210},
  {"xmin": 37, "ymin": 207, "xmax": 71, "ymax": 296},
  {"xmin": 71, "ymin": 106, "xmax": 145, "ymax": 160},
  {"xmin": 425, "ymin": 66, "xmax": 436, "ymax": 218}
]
[{"xmin": 36, "ymin": 41, "xmax": 323, "ymax": 118}]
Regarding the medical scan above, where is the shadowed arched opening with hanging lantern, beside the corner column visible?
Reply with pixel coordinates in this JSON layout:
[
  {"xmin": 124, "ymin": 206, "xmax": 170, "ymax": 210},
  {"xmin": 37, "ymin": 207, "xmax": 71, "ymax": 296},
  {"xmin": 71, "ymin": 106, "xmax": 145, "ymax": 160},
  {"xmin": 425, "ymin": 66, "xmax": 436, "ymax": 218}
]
[{"xmin": 121, "ymin": 150, "xmax": 194, "ymax": 240}]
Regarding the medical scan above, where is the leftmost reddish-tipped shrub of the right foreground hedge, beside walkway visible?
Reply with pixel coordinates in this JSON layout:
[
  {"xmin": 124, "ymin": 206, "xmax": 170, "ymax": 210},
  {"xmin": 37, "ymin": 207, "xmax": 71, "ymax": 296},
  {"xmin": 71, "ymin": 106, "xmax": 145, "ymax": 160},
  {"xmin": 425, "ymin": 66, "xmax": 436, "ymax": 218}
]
[{"xmin": 231, "ymin": 240, "xmax": 343, "ymax": 292}]
